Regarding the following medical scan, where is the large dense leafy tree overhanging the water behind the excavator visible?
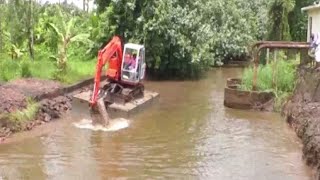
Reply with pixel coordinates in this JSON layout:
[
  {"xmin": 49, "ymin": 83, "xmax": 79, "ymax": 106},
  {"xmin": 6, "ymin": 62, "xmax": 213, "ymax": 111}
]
[{"xmin": 97, "ymin": 0, "xmax": 268, "ymax": 78}]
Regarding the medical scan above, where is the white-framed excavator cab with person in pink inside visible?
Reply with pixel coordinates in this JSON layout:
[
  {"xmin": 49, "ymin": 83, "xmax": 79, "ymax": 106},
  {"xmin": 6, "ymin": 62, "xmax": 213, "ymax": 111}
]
[{"xmin": 121, "ymin": 43, "xmax": 146, "ymax": 84}]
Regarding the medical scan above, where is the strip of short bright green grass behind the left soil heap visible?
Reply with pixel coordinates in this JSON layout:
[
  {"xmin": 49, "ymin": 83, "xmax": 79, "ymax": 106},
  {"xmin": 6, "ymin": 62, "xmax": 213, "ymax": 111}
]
[{"xmin": 0, "ymin": 53, "xmax": 96, "ymax": 84}]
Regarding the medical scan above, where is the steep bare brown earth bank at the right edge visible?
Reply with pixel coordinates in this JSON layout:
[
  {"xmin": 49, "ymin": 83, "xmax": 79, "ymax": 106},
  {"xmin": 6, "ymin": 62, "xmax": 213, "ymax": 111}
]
[{"xmin": 282, "ymin": 68, "xmax": 320, "ymax": 179}]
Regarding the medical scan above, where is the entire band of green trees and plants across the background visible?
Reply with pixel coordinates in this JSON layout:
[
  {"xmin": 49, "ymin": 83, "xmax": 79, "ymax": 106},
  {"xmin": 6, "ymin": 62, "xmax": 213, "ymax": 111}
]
[{"xmin": 0, "ymin": 0, "xmax": 312, "ymax": 82}]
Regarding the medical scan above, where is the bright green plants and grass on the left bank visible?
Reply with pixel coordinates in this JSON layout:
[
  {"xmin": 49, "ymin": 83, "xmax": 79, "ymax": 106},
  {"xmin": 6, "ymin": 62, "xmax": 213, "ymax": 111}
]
[{"xmin": 0, "ymin": 1, "xmax": 95, "ymax": 83}]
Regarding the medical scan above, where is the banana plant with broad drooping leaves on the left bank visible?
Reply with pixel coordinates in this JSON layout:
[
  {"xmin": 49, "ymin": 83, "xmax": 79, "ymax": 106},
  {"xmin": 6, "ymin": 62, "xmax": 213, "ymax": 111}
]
[{"xmin": 48, "ymin": 6, "xmax": 92, "ymax": 73}]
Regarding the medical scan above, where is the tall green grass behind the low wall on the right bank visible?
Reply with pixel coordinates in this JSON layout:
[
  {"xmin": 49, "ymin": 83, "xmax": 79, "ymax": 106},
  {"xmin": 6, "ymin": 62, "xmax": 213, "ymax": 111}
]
[{"xmin": 241, "ymin": 60, "xmax": 298, "ymax": 111}]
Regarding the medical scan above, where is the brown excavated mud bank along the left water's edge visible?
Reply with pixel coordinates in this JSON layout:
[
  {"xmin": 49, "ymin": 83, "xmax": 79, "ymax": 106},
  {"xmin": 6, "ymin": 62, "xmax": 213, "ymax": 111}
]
[{"xmin": 0, "ymin": 78, "xmax": 93, "ymax": 144}]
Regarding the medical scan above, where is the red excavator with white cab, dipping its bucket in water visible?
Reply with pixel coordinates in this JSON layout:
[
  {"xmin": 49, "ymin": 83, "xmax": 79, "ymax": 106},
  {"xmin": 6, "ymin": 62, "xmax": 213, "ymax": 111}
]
[{"xmin": 90, "ymin": 36, "xmax": 146, "ymax": 124}]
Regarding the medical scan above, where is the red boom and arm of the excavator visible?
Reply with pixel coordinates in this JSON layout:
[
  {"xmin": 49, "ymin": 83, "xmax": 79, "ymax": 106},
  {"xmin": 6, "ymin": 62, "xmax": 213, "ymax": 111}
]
[{"xmin": 90, "ymin": 36, "xmax": 123, "ymax": 107}]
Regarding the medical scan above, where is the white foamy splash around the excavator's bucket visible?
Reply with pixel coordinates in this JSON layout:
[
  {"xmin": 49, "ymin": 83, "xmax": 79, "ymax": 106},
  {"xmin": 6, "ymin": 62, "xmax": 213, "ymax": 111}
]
[{"xmin": 73, "ymin": 118, "xmax": 129, "ymax": 132}]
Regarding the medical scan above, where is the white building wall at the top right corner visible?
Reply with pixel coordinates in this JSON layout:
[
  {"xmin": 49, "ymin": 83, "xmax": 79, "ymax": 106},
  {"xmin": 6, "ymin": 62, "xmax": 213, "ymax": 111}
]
[{"xmin": 307, "ymin": 8, "xmax": 320, "ymax": 41}]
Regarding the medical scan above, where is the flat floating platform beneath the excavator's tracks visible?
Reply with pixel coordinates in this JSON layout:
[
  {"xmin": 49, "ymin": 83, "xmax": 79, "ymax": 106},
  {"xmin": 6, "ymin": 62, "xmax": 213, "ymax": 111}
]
[{"xmin": 73, "ymin": 90, "xmax": 159, "ymax": 118}]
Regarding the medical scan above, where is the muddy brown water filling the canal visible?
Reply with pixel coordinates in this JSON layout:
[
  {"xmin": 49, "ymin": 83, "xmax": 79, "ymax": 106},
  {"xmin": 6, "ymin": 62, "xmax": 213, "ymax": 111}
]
[{"xmin": 0, "ymin": 68, "xmax": 311, "ymax": 180}]
